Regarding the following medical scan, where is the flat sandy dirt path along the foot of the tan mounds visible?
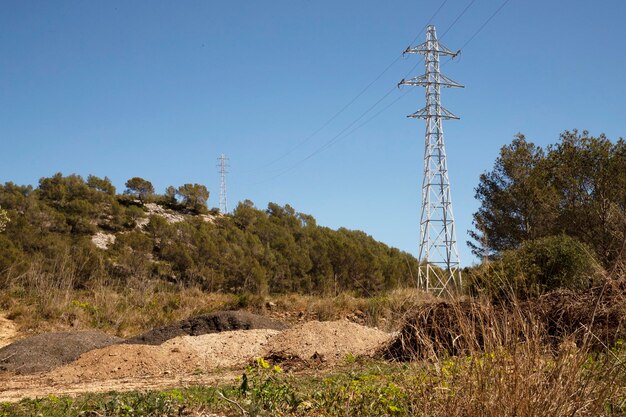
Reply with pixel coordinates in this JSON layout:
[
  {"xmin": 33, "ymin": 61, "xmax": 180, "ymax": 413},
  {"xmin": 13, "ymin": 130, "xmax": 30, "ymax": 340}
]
[{"xmin": 0, "ymin": 368, "xmax": 243, "ymax": 402}]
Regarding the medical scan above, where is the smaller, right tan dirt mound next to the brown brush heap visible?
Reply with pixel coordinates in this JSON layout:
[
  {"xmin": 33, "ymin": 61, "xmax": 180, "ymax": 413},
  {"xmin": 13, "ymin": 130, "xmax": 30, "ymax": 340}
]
[{"xmin": 265, "ymin": 320, "xmax": 390, "ymax": 364}]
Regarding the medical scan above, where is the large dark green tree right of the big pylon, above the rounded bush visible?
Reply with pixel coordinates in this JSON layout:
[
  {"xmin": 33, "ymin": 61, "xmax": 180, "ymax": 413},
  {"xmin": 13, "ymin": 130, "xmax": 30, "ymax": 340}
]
[{"xmin": 469, "ymin": 130, "xmax": 626, "ymax": 268}]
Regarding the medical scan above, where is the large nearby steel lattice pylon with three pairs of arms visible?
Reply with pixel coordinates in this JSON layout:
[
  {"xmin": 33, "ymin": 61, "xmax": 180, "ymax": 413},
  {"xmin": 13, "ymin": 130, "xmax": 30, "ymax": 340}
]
[{"xmin": 398, "ymin": 25, "xmax": 463, "ymax": 295}]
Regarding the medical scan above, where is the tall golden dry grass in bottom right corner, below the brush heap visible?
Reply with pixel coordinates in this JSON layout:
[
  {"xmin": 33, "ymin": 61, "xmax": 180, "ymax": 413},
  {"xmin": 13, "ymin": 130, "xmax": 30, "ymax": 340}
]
[{"xmin": 394, "ymin": 343, "xmax": 626, "ymax": 417}]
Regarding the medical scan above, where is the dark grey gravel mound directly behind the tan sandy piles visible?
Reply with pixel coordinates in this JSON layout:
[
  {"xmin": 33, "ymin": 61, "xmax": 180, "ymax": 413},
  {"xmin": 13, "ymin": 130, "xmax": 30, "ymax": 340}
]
[{"xmin": 126, "ymin": 311, "xmax": 288, "ymax": 345}]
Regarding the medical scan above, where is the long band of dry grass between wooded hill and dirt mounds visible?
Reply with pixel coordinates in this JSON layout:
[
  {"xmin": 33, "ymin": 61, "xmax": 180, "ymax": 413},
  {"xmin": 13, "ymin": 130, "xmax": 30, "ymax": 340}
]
[{"xmin": 0, "ymin": 255, "xmax": 432, "ymax": 337}]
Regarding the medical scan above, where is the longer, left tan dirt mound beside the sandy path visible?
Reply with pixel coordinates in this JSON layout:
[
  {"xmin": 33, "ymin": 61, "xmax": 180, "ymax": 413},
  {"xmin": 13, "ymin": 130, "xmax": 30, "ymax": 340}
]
[{"xmin": 49, "ymin": 329, "xmax": 279, "ymax": 383}]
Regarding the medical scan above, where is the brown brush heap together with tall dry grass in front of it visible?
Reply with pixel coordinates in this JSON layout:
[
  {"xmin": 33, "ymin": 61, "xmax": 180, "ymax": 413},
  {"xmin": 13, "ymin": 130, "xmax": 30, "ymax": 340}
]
[{"xmin": 372, "ymin": 281, "xmax": 626, "ymax": 416}]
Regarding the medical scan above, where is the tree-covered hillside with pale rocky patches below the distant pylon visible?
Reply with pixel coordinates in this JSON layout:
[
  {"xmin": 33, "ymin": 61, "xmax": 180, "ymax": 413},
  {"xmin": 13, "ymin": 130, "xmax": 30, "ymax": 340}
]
[{"xmin": 0, "ymin": 174, "xmax": 417, "ymax": 295}]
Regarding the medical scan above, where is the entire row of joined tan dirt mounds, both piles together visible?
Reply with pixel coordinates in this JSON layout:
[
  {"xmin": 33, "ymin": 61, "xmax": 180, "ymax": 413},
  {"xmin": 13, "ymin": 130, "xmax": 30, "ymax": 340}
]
[{"xmin": 47, "ymin": 320, "xmax": 389, "ymax": 383}]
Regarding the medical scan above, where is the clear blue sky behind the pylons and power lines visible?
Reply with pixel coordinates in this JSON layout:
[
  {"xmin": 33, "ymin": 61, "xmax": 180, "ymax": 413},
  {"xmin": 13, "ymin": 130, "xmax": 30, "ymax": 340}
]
[{"xmin": 0, "ymin": 0, "xmax": 626, "ymax": 265}]
